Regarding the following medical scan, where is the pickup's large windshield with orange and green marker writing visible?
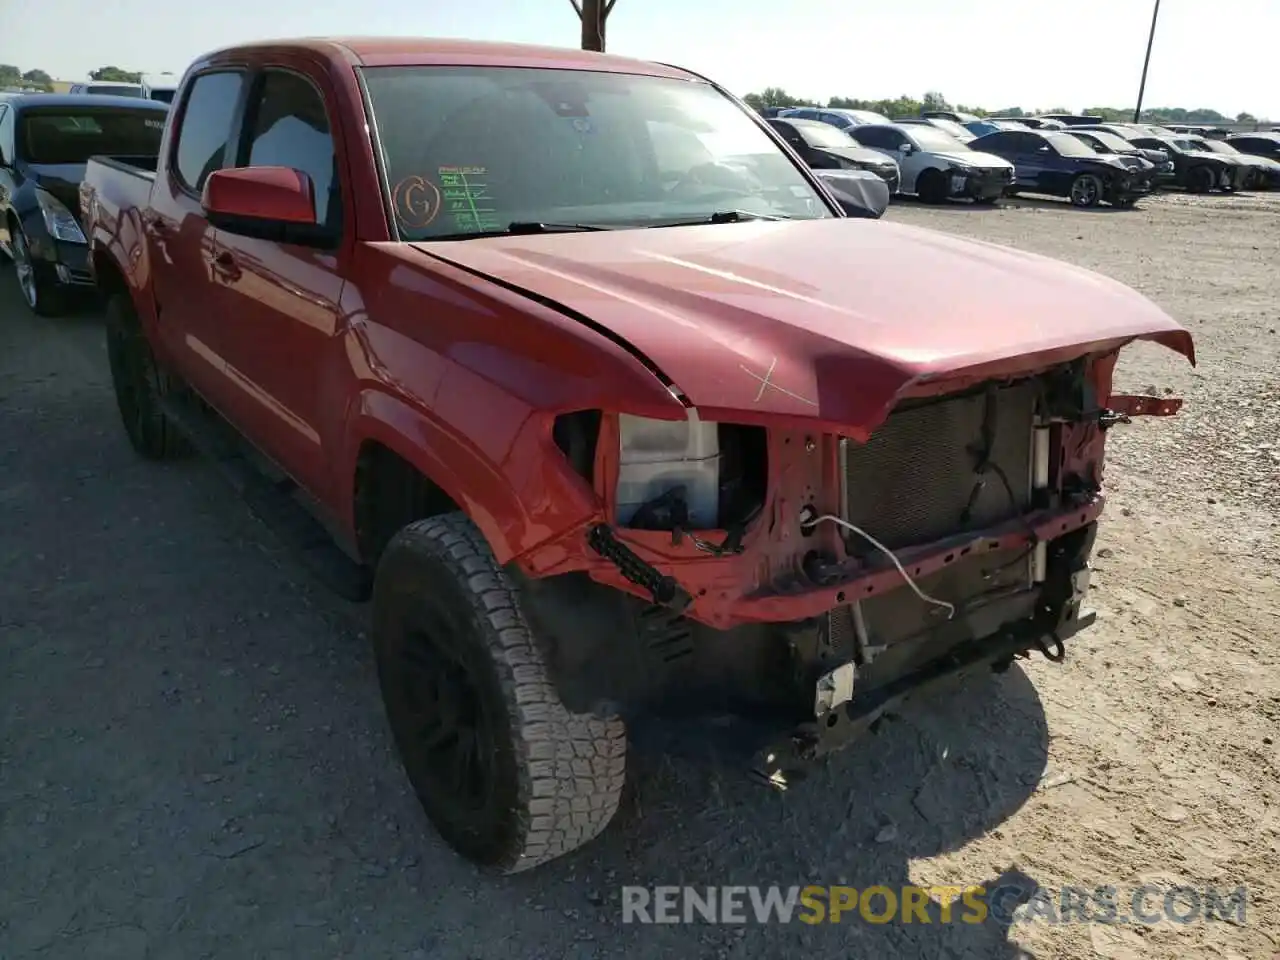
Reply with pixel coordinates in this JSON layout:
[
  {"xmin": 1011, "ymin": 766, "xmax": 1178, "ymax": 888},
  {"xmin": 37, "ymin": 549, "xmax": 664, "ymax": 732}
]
[{"xmin": 365, "ymin": 67, "xmax": 835, "ymax": 239}]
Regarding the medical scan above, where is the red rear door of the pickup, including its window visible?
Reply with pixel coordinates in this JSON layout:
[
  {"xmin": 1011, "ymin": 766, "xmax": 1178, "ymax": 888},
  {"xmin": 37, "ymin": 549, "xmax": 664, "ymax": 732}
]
[{"xmin": 145, "ymin": 68, "xmax": 247, "ymax": 407}]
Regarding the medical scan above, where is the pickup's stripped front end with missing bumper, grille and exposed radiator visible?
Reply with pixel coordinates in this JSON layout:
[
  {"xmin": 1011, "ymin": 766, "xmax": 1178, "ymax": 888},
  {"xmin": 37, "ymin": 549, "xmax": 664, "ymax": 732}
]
[{"xmin": 517, "ymin": 353, "xmax": 1179, "ymax": 786}]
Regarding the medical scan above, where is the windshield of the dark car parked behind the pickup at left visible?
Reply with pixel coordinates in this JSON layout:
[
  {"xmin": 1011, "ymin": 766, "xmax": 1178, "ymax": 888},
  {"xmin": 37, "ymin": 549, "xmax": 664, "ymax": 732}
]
[{"xmin": 17, "ymin": 106, "xmax": 165, "ymax": 164}]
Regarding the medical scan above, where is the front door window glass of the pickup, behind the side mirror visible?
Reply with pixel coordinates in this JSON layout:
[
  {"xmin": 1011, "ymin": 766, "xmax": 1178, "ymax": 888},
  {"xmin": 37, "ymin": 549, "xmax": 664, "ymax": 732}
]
[{"xmin": 246, "ymin": 70, "xmax": 342, "ymax": 227}]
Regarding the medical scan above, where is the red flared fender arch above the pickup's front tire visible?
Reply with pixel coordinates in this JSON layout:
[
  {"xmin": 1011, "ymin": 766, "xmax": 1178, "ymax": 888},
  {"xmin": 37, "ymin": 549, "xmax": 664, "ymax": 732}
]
[{"xmin": 338, "ymin": 389, "xmax": 537, "ymax": 563}]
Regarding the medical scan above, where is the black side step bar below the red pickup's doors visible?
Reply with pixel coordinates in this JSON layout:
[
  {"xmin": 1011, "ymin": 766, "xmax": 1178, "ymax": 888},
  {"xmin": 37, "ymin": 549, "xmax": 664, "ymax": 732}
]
[{"xmin": 163, "ymin": 394, "xmax": 372, "ymax": 603}]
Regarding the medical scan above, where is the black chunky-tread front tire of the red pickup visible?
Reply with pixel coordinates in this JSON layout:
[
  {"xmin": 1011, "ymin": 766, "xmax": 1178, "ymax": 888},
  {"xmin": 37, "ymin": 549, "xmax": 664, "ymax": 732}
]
[{"xmin": 372, "ymin": 513, "xmax": 626, "ymax": 873}]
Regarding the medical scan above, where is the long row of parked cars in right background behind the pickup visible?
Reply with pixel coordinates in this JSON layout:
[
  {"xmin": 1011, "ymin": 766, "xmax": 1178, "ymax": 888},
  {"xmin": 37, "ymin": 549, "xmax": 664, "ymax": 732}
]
[{"xmin": 765, "ymin": 108, "xmax": 1280, "ymax": 207}]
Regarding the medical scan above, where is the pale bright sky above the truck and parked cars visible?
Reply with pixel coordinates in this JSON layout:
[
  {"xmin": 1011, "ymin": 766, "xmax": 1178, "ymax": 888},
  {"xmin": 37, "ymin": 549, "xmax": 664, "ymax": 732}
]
[{"xmin": 0, "ymin": 0, "xmax": 1280, "ymax": 120}]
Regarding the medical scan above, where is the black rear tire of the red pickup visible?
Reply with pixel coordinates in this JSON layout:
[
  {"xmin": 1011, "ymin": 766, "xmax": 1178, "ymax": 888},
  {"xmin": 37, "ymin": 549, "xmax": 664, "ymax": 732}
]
[{"xmin": 106, "ymin": 293, "xmax": 191, "ymax": 460}]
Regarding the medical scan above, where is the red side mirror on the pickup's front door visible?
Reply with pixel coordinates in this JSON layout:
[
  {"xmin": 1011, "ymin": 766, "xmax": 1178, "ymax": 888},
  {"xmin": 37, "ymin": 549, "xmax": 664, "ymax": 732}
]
[{"xmin": 200, "ymin": 166, "xmax": 335, "ymax": 247}]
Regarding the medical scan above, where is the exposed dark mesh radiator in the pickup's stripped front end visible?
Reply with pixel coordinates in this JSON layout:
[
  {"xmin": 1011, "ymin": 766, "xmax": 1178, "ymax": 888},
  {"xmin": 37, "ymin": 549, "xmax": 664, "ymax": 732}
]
[{"xmin": 842, "ymin": 381, "xmax": 1037, "ymax": 554}]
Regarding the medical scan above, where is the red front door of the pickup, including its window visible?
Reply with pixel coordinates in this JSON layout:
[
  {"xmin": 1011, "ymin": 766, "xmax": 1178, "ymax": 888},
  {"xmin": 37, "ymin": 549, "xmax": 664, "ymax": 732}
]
[{"xmin": 202, "ymin": 64, "xmax": 349, "ymax": 499}]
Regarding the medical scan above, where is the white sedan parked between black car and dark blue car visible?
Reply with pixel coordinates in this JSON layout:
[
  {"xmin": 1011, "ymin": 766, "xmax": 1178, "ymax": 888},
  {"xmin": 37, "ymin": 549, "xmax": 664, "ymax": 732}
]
[{"xmin": 846, "ymin": 123, "xmax": 1014, "ymax": 204}]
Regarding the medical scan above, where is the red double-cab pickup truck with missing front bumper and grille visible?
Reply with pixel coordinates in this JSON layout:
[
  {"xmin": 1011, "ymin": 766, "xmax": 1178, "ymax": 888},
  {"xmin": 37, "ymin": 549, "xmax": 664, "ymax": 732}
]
[{"xmin": 81, "ymin": 38, "xmax": 1194, "ymax": 870}]
